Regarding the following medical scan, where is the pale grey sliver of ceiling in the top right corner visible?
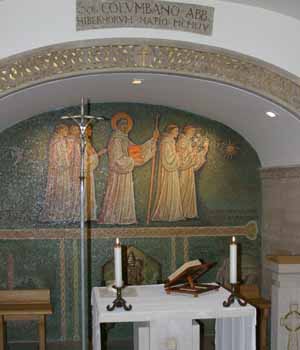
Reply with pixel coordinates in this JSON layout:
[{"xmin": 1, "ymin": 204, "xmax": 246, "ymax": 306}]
[{"xmin": 222, "ymin": 0, "xmax": 300, "ymax": 19}]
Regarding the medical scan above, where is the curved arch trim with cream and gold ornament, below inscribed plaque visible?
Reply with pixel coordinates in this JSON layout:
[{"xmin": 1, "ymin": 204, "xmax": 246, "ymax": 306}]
[{"xmin": 0, "ymin": 39, "xmax": 300, "ymax": 116}]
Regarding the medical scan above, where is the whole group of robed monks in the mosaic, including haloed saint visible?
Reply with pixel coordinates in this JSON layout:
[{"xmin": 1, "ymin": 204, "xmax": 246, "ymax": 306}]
[{"xmin": 40, "ymin": 112, "xmax": 209, "ymax": 225}]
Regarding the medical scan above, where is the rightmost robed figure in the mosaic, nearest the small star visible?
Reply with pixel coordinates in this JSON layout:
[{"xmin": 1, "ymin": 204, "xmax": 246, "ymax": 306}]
[{"xmin": 176, "ymin": 125, "xmax": 209, "ymax": 219}]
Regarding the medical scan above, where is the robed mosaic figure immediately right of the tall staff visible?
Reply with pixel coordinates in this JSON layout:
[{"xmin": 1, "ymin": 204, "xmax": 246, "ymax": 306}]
[{"xmin": 152, "ymin": 124, "xmax": 184, "ymax": 221}]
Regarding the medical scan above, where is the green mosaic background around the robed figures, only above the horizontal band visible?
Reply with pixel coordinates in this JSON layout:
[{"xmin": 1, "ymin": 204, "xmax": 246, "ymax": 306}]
[{"xmin": 0, "ymin": 103, "xmax": 260, "ymax": 228}]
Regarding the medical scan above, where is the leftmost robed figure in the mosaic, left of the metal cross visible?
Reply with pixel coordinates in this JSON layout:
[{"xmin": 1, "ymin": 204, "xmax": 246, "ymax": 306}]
[{"xmin": 40, "ymin": 124, "xmax": 73, "ymax": 222}]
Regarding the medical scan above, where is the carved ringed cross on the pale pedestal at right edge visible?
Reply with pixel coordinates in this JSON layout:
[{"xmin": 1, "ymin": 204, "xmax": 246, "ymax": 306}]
[{"xmin": 280, "ymin": 304, "xmax": 300, "ymax": 350}]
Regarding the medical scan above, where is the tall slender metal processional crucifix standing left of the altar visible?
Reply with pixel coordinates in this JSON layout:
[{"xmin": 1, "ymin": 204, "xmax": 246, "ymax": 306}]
[{"xmin": 61, "ymin": 97, "xmax": 106, "ymax": 350}]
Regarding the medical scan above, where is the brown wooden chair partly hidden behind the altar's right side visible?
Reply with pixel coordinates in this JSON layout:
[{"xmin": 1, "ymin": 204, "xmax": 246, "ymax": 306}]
[{"xmin": 240, "ymin": 284, "xmax": 271, "ymax": 350}]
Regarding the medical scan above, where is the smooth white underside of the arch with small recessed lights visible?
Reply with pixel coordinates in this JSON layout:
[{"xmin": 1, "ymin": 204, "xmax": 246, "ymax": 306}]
[{"xmin": 0, "ymin": 73, "xmax": 300, "ymax": 167}]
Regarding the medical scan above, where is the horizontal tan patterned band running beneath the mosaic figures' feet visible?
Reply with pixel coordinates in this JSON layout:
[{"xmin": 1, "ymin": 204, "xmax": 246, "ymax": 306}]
[{"xmin": 0, "ymin": 221, "xmax": 258, "ymax": 240}]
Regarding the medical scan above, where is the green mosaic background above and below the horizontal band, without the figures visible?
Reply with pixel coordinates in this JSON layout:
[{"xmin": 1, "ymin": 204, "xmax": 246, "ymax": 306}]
[{"xmin": 0, "ymin": 103, "xmax": 261, "ymax": 340}]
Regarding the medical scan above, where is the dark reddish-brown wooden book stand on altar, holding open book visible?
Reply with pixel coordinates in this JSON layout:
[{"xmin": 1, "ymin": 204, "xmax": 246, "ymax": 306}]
[{"xmin": 164, "ymin": 263, "xmax": 220, "ymax": 297}]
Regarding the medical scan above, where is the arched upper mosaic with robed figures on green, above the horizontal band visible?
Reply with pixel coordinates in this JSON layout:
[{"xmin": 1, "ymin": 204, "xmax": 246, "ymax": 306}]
[{"xmin": 0, "ymin": 104, "xmax": 260, "ymax": 228}]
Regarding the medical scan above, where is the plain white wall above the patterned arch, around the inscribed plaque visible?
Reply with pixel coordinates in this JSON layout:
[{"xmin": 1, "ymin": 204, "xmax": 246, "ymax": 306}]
[{"xmin": 0, "ymin": 0, "xmax": 300, "ymax": 76}]
